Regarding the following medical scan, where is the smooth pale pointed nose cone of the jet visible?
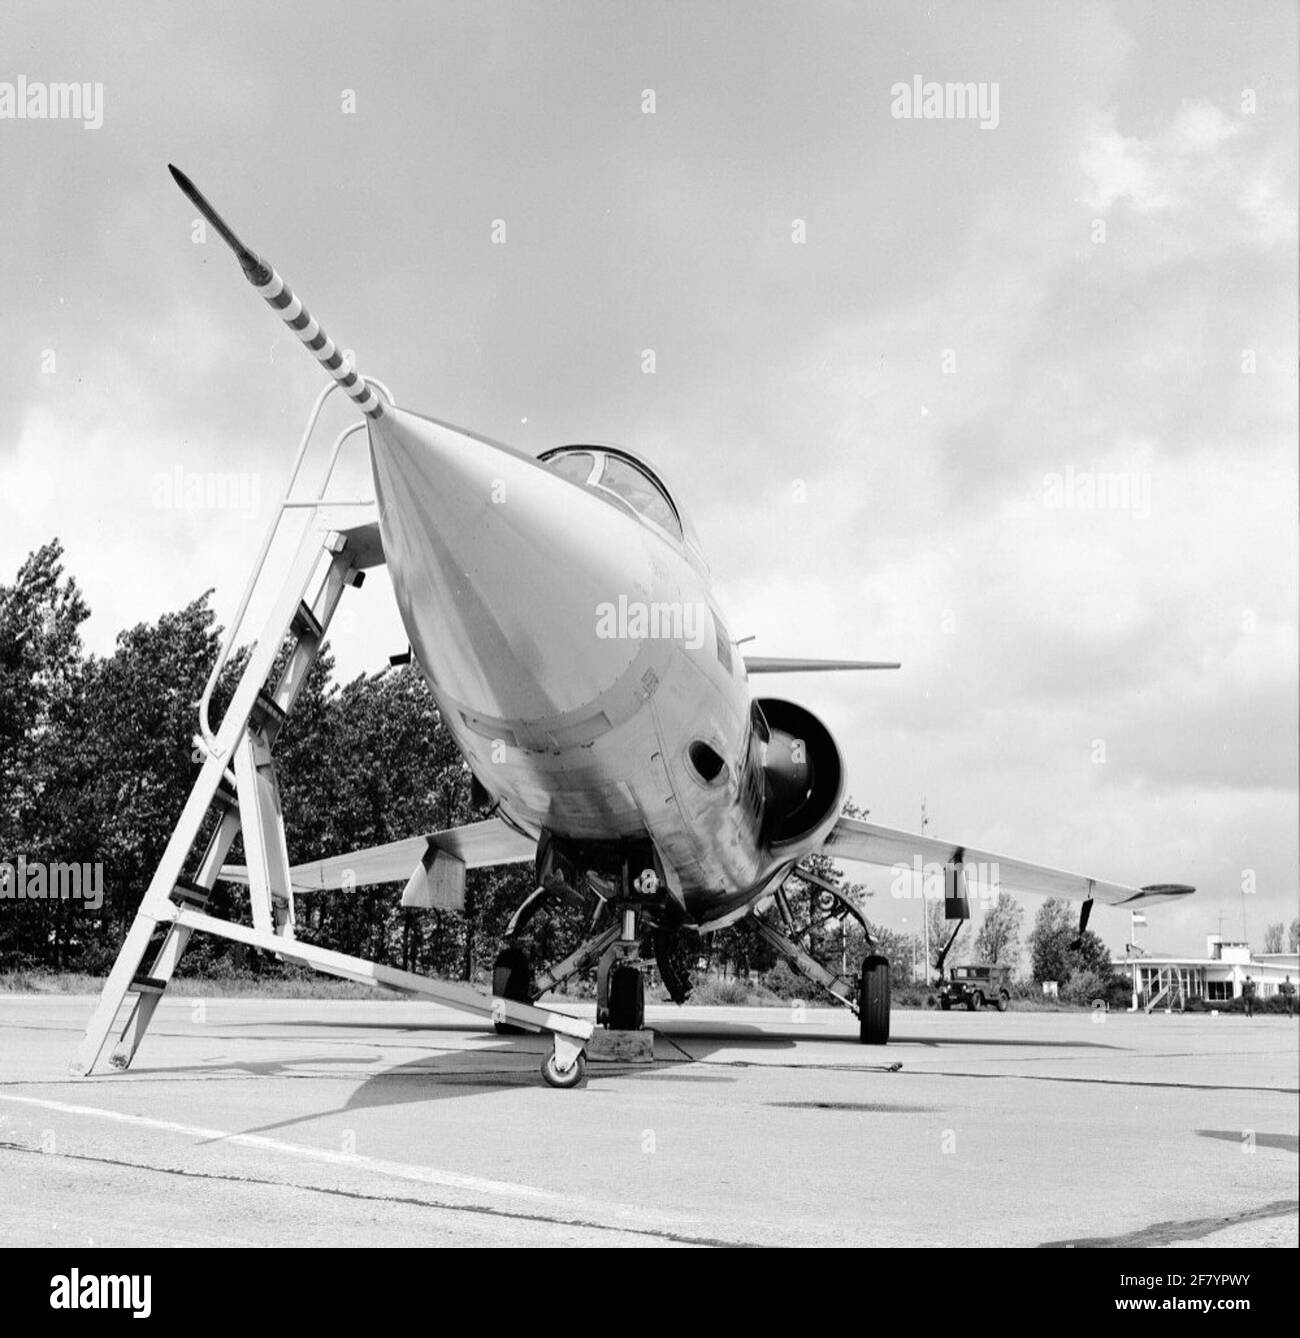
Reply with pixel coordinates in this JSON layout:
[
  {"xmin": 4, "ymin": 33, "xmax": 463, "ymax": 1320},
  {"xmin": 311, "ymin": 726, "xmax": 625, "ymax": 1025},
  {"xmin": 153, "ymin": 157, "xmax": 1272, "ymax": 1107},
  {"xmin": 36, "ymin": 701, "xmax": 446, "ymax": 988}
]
[{"xmin": 369, "ymin": 409, "xmax": 651, "ymax": 720}]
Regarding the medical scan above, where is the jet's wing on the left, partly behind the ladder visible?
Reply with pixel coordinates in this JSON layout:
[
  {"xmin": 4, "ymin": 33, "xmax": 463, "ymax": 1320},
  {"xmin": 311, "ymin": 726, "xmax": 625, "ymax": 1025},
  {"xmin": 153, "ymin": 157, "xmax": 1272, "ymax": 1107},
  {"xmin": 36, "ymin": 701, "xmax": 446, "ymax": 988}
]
[{"xmin": 221, "ymin": 818, "xmax": 538, "ymax": 892}]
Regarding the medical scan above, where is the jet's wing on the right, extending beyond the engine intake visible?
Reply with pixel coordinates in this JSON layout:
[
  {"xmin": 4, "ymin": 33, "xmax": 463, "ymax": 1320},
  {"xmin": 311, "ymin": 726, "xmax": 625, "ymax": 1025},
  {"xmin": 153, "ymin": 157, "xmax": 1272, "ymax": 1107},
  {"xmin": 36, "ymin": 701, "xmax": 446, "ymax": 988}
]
[{"xmin": 821, "ymin": 818, "xmax": 1196, "ymax": 906}]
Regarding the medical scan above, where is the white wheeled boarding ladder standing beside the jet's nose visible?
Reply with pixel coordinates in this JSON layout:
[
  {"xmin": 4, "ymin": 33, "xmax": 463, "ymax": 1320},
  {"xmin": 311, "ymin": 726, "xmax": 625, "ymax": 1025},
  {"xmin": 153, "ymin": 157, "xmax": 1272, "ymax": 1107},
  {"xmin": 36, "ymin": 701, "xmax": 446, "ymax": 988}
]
[{"xmin": 71, "ymin": 381, "xmax": 594, "ymax": 1074}]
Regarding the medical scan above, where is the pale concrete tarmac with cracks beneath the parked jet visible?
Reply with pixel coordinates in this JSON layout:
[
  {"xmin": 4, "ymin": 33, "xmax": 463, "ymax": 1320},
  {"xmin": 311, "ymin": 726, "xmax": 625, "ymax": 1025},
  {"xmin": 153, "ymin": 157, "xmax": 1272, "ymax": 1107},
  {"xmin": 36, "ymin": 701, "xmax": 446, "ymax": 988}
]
[{"xmin": 0, "ymin": 994, "xmax": 1300, "ymax": 1247}]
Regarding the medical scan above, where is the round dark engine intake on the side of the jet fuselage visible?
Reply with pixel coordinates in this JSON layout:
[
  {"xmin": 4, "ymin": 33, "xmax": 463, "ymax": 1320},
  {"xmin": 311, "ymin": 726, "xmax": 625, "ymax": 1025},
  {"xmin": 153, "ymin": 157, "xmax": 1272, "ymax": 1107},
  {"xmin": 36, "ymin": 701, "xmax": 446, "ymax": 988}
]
[{"xmin": 758, "ymin": 697, "xmax": 844, "ymax": 848}]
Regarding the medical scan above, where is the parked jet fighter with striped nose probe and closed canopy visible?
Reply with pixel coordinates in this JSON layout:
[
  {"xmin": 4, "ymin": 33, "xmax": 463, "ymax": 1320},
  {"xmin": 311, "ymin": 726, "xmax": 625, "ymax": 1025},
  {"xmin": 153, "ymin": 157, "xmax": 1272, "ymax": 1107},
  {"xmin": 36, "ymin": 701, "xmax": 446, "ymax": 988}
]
[{"xmin": 171, "ymin": 169, "xmax": 1192, "ymax": 1059}]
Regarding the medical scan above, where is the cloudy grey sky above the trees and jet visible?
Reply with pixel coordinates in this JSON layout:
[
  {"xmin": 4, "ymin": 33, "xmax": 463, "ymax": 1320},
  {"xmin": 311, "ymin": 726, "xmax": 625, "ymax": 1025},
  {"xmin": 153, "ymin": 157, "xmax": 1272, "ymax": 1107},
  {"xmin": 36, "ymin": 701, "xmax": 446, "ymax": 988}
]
[{"xmin": 0, "ymin": 0, "xmax": 1300, "ymax": 954}]
